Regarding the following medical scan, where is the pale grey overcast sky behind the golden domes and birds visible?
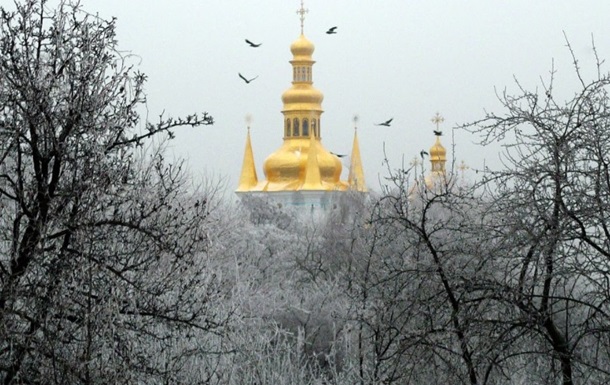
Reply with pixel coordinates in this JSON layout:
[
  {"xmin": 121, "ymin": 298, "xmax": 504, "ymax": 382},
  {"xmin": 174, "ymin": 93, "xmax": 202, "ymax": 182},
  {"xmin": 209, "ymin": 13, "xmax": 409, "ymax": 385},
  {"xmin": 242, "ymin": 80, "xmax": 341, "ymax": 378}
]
[{"xmin": 82, "ymin": 0, "xmax": 610, "ymax": 190}]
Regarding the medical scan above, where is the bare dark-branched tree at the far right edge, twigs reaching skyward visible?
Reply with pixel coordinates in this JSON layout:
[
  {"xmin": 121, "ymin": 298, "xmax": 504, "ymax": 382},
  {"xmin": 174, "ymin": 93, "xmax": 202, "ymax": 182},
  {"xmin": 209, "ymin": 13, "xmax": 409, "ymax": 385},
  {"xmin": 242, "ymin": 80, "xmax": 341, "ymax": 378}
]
[{"xmin": 460, "ymin": 39, "xmax": 610, "ymax": 385}]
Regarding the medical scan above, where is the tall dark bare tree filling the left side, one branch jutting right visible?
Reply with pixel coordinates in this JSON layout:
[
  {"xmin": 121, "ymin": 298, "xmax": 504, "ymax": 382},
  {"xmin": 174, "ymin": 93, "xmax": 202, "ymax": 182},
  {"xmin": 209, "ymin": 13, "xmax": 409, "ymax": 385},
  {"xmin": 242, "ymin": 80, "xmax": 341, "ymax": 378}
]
[{"xmin": 0, "ymin": 0, "xmax": 226, "ymax": 384}]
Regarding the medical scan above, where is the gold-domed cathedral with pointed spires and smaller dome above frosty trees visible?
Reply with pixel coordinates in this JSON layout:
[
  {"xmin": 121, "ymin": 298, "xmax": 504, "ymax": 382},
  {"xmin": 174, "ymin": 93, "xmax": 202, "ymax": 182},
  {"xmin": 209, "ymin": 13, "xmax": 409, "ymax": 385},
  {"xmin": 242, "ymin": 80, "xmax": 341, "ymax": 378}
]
[{"xmin": 236, "ymin": 3, "xmax": 446, "ymax": 207}]
